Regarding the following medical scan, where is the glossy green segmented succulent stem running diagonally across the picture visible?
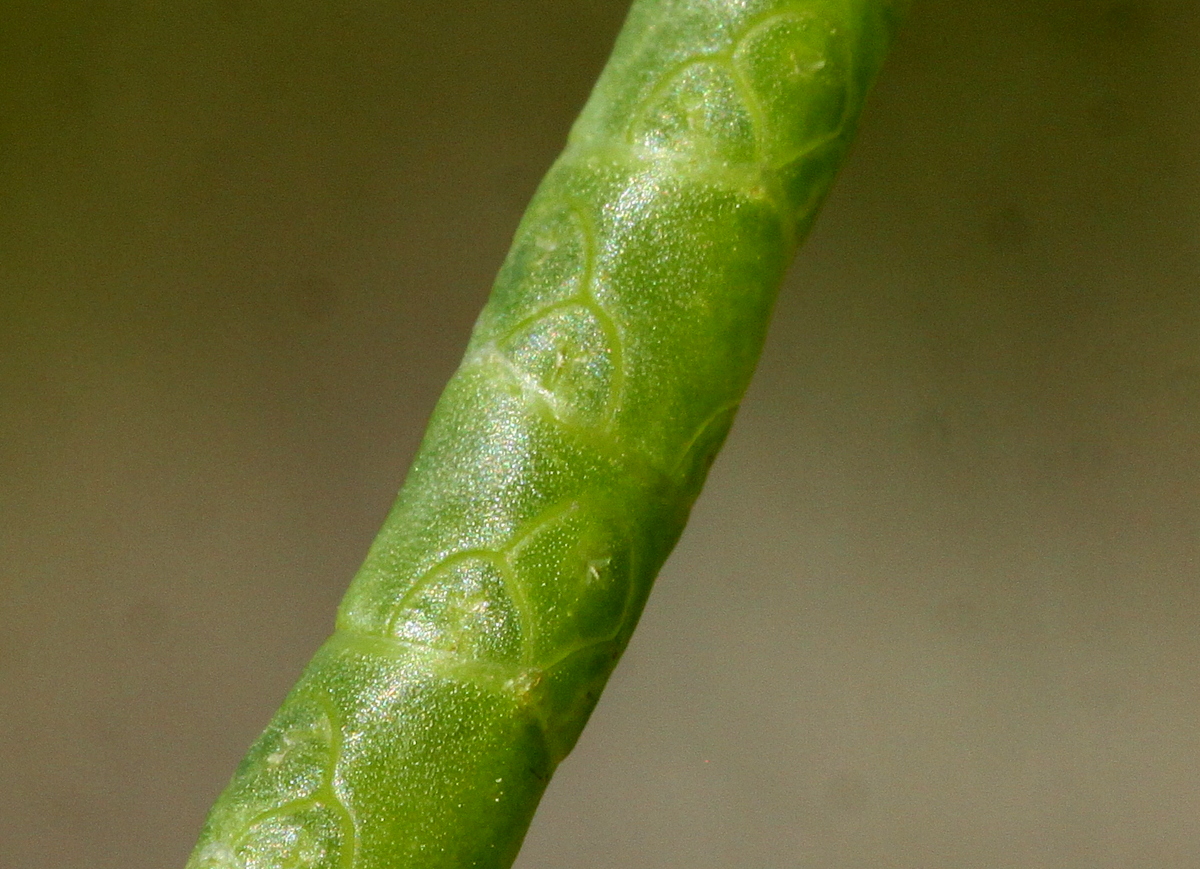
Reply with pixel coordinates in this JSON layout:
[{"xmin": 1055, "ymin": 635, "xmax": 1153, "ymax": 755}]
[{"xmin": 188, "ymin": 0, "xmax": 899, "ymax": 869}]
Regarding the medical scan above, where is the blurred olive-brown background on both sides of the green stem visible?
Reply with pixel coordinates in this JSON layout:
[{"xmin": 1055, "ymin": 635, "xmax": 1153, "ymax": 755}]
[{"xmin": 0, "ymin": 0, "xmax": 1200, "ymax": 869}]
